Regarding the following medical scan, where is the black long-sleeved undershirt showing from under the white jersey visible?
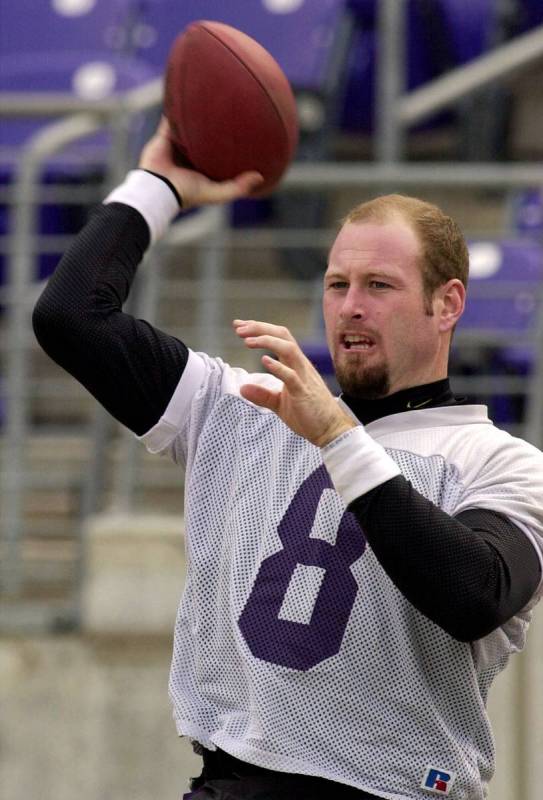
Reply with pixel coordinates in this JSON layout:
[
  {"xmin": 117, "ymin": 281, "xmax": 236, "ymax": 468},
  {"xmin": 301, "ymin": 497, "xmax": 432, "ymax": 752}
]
[{"xmin": 33, "ymin": 203, "xmax": 540, "ymax": 641}]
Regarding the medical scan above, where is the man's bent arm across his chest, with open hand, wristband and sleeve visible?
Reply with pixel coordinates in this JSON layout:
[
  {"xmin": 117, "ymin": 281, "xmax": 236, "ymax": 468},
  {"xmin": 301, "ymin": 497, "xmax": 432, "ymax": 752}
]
[{"xmin": 234, "ymin": 320, "xmax": 541, "ymax": 641}]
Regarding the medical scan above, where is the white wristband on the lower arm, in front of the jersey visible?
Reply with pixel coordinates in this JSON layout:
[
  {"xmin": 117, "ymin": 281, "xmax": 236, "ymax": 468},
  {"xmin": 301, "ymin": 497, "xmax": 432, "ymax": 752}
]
[{"xmin": 321, "ymin": 425, "xmax": 401, "ymax": 505}]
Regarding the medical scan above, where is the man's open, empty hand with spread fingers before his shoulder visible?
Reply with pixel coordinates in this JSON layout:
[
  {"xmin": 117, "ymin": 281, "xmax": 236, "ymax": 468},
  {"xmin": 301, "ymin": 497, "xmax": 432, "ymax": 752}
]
[{"xmin": 233, "ymin": 319, "xmax": 356, "ymax": 447}]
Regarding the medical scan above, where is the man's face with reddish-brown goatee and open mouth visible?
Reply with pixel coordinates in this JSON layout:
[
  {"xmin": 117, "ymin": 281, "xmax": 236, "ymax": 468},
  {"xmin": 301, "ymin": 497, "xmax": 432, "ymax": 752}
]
[{"xmin": 323, "ymin": 219, "xmax": 448, "ymax": 399}]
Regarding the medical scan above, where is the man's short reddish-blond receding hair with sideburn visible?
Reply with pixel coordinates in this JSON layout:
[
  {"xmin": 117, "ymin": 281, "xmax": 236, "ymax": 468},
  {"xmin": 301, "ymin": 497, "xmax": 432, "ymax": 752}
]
[{"xmin": 342, "ymin": 194, "xmax": 469, "ymax": 305}]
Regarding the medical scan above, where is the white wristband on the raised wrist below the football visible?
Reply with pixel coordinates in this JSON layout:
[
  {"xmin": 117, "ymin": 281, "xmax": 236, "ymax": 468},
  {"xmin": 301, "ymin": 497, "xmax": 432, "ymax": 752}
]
[{"xmin": 104, "ymin": 169, "xmax": 179, "ymax": 244}]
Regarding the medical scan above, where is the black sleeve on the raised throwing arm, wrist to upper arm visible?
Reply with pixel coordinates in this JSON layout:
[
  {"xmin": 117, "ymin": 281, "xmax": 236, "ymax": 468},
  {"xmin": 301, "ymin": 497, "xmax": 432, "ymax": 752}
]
[{"xmin": 33, "ymin": 194, "xmax": 187, "ymax": 434}]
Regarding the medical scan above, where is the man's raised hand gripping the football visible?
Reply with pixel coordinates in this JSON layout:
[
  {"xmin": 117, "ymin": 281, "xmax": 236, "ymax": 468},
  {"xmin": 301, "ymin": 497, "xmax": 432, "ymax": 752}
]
[{"xmin": 139, "ymin": 117, "xmax": 263, "ymax": 210}]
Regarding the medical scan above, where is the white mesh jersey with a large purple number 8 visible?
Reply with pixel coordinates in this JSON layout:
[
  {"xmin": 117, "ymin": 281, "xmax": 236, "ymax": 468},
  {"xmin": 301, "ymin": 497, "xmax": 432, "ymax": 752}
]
[{"xmin": 141, "ymin": 352, "xmax": 543, "ymax": 800}]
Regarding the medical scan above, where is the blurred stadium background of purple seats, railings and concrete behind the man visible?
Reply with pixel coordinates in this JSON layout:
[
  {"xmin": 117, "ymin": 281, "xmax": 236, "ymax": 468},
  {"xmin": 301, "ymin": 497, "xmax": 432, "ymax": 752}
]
[{"xmin": 0, "ymin": 0, "xmax": 543, "ymax": 800}]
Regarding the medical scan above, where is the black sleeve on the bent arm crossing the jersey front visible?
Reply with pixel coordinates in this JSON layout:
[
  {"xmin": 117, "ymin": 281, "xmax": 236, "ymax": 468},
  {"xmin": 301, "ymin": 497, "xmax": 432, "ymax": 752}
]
[{"xmin": 326, "ymin": 428, "xmax": 540, "ymax": 641}]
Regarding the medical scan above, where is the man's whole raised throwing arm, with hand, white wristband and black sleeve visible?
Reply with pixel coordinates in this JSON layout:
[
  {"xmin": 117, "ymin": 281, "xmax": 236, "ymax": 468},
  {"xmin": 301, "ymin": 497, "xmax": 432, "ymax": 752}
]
[{"xmin": 33, "ymin": 115, "xmax": 258, "ymax": 435}]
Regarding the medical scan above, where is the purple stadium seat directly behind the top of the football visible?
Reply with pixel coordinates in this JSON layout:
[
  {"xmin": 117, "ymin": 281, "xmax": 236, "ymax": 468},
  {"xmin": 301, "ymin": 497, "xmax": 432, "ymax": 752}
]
[{"xmin": 129, "ymin": 0, "xmax": 345, "ymax": 89}]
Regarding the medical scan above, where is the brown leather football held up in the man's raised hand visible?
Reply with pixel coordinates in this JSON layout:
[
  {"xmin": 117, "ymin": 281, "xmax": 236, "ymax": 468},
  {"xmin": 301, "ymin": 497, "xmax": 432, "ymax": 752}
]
[{"xmin": 164, "ymin": 20, "xmax": 298, "ymax": 196}]
